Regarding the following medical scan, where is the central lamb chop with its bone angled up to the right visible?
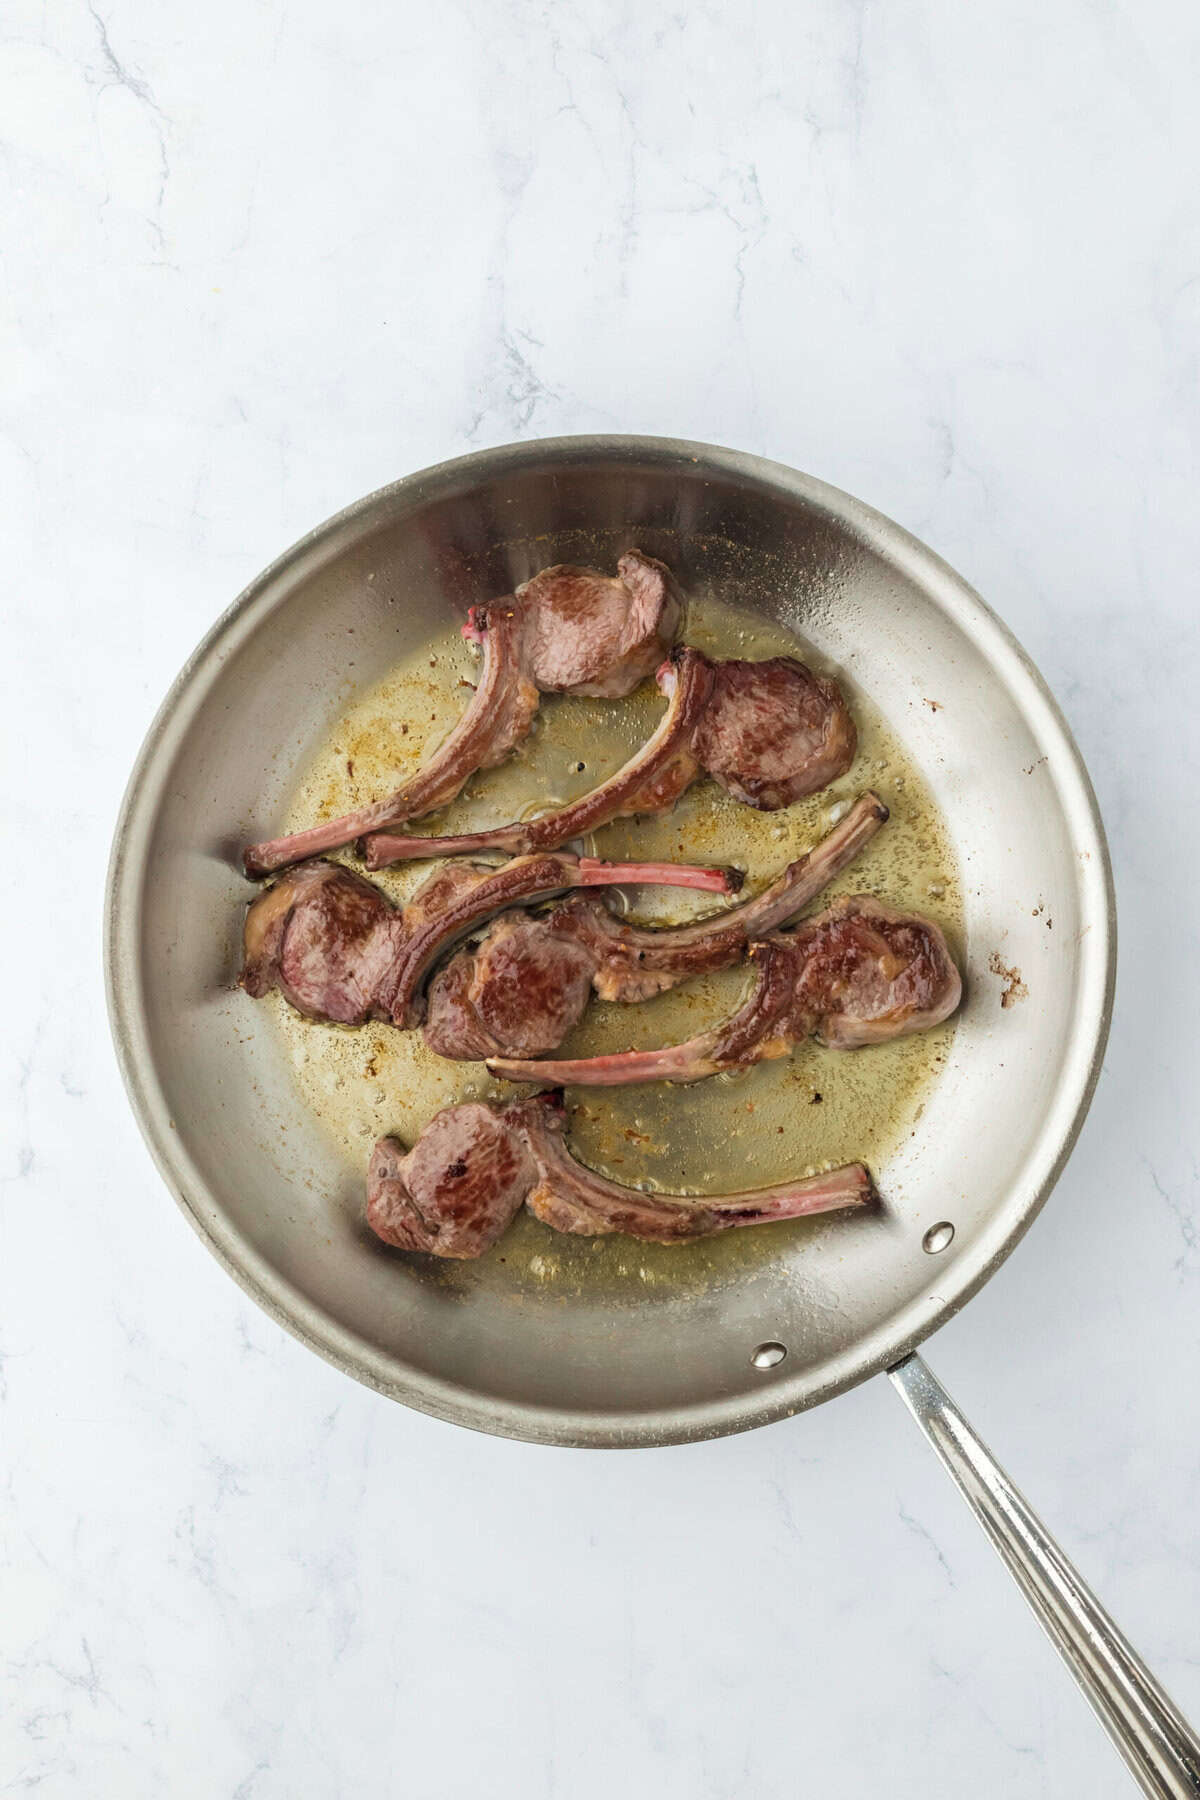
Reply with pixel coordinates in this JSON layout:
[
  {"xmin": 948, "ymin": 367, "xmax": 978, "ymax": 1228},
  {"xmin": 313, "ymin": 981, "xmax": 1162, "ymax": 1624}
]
[{"xmin": 425, "ymin": 794, "xmax": 887, "ymax": 1062}]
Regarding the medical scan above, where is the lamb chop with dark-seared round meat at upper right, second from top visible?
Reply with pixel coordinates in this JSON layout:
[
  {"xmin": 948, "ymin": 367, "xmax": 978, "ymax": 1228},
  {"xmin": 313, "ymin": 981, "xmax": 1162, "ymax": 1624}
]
[{"xmin": 365, "ymin": 646, "xmax": 858, "ymax": 869}]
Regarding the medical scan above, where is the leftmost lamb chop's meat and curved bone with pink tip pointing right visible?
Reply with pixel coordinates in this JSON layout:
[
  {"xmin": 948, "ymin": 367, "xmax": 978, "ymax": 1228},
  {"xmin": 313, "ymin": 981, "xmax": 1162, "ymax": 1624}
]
[{"xmin": 241, "ymin": 853, "xmax": 739, "ymax": 1026}]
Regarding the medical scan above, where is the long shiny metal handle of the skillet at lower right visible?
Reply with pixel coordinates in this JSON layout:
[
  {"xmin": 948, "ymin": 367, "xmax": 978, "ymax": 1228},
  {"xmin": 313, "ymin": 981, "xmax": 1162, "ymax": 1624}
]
[{"xmin": 889, "ymin": 1355, "xmax": 1200, "ymax": 1800}]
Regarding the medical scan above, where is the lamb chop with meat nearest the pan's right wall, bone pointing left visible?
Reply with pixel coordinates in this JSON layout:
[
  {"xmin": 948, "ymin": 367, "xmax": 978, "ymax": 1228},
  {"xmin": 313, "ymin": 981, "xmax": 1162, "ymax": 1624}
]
[{"xmin": 488, "ymin": 895, "xmax": 963, "ymax": 1087}]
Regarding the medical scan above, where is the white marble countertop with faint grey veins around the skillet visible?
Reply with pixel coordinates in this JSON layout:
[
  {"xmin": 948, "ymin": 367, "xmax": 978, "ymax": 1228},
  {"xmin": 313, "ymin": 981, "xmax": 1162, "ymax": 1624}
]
[{"xmin": 0, "ymin": 0, "xmax": 1200, "ymax": 1800}]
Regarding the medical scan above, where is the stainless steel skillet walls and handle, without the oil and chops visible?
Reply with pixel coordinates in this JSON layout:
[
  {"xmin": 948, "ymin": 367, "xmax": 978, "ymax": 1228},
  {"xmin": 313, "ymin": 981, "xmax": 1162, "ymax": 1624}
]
[{"xmin": 106, "ymin": 437, "xmax": 1200, "ymax": 1795}]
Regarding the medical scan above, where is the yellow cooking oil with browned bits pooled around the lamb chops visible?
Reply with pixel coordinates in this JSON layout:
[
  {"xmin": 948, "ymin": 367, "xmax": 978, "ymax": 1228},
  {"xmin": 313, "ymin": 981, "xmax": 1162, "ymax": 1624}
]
[{"xmin": 272, "ymin": 598, "xmax": 963, "ymax": 1300}]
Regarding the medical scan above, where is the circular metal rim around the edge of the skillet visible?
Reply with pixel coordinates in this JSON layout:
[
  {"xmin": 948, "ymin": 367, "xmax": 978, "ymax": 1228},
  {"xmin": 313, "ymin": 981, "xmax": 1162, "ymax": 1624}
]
[{"xmin": 104, "ymin": 434, "xmax": 1115, "ymax": 1447}]
